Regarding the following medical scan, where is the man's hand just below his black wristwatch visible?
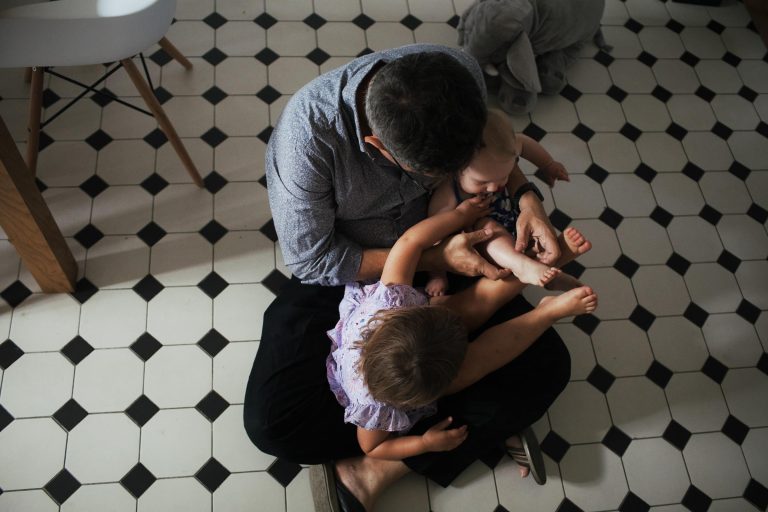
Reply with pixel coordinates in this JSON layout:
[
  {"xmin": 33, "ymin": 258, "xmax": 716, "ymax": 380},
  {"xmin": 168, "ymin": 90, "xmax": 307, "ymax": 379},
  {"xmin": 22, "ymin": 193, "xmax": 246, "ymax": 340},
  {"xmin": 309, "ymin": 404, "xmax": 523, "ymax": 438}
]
[{"xmin": 515, "ymin": 198, "xmax": 560, "ymax": 265}]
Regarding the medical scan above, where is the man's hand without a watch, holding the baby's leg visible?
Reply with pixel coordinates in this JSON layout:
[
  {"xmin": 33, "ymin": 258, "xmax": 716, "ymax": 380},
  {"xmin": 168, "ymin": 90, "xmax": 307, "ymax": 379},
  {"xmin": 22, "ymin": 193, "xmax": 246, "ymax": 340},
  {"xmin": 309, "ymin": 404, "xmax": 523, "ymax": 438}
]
[{"xmin": 431, "ymin": 229, "xmax": 511, "ymax": 280}]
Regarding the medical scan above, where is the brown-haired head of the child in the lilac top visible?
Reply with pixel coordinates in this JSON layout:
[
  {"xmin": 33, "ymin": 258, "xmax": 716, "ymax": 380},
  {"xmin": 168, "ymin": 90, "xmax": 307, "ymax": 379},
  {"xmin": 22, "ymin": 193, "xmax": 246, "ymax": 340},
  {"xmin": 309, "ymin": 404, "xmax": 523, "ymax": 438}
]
[{"xmin": 359, "ymin": 306, "xmax": 467, "ymax": 410}]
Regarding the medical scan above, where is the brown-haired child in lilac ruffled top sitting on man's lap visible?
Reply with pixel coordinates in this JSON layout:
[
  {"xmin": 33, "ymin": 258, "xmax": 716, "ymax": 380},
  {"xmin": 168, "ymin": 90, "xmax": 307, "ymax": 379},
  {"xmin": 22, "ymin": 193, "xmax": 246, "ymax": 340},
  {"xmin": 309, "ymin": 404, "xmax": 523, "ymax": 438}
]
[{"xmin": 327, "ymin": 197, "xmax": 597, "ymax": 460}]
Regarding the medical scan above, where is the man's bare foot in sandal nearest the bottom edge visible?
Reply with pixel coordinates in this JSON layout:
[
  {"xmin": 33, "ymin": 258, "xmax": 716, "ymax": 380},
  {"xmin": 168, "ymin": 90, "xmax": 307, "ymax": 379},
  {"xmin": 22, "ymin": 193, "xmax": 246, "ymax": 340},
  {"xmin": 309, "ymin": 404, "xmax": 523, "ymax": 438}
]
[{"xmin": 336, "ymin": 456, "xmax": 410, "ymax": 510}]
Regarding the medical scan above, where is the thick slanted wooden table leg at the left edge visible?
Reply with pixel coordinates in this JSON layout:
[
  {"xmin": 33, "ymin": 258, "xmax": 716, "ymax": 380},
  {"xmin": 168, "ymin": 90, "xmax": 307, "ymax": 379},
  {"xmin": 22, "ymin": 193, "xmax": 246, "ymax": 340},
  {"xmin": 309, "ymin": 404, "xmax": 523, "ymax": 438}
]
[{"xmin": 0, "ymin": 115, "xmax": 77, "ymax": 293}]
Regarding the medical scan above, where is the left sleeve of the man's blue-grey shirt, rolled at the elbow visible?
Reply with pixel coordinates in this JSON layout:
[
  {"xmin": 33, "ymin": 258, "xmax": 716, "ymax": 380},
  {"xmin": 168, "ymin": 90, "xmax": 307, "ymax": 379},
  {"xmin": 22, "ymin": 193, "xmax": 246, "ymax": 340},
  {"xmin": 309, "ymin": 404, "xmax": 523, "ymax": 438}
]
[{"xmin": 265, "ymin": 111, "xmax": 363, "ymax": 286}]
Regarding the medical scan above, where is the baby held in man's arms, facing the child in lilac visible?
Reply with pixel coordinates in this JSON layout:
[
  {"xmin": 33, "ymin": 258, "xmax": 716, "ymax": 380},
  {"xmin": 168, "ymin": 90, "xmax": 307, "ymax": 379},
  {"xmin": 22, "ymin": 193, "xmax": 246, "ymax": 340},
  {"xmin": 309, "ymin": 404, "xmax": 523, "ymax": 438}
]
[{"xmin": 426, "ymin": 109, "xmax": 591, "ymax": 296}]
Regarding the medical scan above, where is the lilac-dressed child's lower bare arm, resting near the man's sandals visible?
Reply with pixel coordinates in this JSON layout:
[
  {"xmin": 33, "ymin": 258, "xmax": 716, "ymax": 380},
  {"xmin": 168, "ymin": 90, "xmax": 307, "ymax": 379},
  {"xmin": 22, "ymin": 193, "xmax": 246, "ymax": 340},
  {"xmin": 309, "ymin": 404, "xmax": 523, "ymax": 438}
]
[{"xmin": 357, "ymin": 417, "xmax": 467, "ymax": 460}]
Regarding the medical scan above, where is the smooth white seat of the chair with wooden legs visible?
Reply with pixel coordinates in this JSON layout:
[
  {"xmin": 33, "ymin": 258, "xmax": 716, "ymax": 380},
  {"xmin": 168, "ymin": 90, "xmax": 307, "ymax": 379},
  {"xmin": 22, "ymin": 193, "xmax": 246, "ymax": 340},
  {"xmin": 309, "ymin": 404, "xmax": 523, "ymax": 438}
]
[{"xmin": 0, "ymin": 0, "xmax": 176, "ymax": 68}]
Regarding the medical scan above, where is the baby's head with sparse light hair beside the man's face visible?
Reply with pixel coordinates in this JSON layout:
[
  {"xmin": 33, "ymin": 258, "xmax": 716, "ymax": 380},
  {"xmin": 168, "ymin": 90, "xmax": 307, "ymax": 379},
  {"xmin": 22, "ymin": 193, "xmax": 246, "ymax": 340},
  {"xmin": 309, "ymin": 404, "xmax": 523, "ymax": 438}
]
[{"xmin": 458, "ymin": 108, "xmax": 519, "ymax": 195}]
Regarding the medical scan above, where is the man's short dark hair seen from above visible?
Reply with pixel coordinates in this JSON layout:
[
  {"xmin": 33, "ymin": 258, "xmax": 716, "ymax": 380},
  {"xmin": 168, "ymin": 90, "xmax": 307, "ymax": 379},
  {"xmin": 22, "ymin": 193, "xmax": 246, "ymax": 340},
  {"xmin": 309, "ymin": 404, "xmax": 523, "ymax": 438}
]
[{"xmin": 365, "ymin": 52, "xmax": 486, "ymax": 174}]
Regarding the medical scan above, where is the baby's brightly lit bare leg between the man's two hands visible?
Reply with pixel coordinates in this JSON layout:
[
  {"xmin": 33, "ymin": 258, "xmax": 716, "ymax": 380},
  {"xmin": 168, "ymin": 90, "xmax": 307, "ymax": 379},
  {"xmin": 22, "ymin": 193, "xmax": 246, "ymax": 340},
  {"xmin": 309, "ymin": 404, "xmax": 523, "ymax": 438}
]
[{"xmin": 475, "ymin": 218, "xmax": 560, "ymax": 286}]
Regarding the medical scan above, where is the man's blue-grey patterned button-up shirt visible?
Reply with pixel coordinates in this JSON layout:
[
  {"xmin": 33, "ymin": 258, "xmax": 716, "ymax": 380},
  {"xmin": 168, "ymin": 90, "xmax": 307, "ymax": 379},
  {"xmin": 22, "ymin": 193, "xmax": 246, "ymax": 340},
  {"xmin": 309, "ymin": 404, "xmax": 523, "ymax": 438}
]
[{"xmin": 265, "ymin": 44, "xmax": 485, "ymax": 285}]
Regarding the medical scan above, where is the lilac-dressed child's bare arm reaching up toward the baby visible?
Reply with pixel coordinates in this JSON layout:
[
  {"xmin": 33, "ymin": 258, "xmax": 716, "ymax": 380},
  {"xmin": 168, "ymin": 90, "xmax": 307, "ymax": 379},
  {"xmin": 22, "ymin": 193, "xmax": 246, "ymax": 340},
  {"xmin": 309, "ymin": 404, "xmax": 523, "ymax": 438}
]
[{"xmin": 381, "ymin": 197, "xmax": 490, "ymax": 285}]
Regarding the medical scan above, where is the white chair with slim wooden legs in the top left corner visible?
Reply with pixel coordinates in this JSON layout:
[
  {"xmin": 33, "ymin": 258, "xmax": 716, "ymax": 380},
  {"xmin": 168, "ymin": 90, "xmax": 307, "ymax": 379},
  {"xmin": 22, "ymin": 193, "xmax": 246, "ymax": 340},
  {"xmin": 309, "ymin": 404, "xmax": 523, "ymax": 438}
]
[{"xmin": 0, "ymin": 0, "xmax": 203, "ymax": 187}]
